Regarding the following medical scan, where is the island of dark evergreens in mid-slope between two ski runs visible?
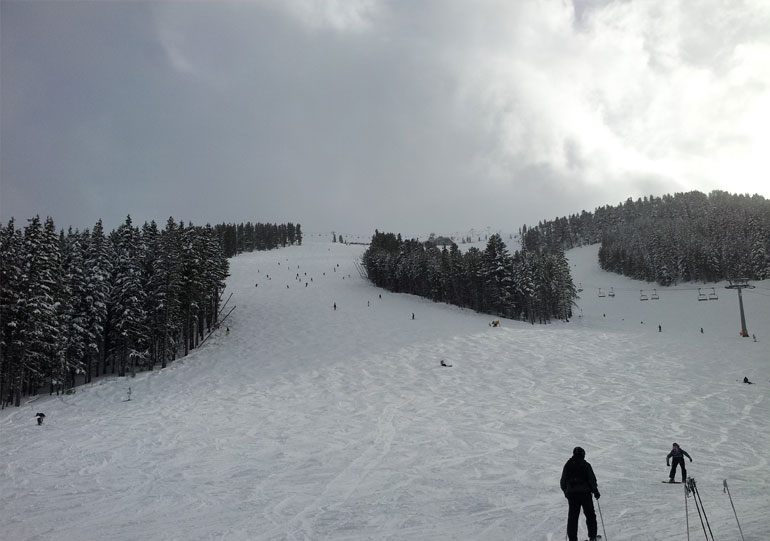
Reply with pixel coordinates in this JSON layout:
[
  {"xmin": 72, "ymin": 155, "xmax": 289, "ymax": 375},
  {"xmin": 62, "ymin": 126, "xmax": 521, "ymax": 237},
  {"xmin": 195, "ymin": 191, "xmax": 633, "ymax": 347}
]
[{"xmin": 362, "ymin": 231, "xmax": 577, "ymax": 323}]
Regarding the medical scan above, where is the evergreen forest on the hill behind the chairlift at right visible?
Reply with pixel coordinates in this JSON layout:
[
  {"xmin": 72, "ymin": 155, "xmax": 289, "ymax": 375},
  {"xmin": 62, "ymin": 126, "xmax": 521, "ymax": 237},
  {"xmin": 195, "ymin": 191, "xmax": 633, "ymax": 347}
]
[{"xmin": 521, "ymin": 191, "xmax": 770, "ymax": 285}]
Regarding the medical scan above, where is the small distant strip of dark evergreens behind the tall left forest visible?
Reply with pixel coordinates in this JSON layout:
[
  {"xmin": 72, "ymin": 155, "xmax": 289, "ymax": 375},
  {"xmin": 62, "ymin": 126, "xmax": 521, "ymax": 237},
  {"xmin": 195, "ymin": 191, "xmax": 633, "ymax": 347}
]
[{"xmin": 214, "ymin": 222, "xmax": 302, "ymax": 258}]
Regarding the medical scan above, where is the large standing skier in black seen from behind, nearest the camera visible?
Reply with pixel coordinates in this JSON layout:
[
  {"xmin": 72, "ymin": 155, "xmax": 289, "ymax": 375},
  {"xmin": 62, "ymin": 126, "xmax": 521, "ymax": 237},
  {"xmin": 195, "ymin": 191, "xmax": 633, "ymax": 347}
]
[{"xmin": 560, "ymin": 447, "xmax": 599, "ymax": 541}]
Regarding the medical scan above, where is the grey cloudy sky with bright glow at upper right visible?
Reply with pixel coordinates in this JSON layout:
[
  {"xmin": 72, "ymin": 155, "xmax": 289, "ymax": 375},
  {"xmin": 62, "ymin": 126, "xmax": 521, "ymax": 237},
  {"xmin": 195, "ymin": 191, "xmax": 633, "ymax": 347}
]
[{"xmin": 0, "ymin": 0, "xmax": 770, "ymax": 234}]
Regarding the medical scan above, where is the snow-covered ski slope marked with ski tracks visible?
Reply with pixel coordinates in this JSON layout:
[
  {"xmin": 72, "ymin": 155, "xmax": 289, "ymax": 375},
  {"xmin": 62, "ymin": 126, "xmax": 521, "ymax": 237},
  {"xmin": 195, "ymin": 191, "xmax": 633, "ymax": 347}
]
[{"xmin": 0, "ymin": 238, "xmax": 770, "ymax": 541}]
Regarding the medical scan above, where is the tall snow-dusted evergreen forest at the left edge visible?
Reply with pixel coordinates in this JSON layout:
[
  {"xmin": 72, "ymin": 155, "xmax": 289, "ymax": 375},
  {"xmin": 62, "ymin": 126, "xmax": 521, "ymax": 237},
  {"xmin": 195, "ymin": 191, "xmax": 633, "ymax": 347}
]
[{"xmin": 0, "ymin": 213, "xmax": 229, "ymax": 407}]
